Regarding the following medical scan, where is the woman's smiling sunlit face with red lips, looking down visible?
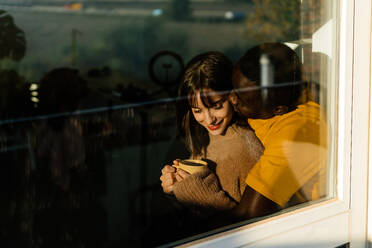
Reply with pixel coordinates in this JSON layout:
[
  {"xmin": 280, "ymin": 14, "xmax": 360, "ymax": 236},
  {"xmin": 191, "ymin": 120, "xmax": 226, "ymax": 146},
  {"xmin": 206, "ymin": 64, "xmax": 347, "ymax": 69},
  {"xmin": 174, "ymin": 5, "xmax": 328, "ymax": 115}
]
[{"xmin": 191, "ymin": 90, "xmax": 233, "ymax": 135}]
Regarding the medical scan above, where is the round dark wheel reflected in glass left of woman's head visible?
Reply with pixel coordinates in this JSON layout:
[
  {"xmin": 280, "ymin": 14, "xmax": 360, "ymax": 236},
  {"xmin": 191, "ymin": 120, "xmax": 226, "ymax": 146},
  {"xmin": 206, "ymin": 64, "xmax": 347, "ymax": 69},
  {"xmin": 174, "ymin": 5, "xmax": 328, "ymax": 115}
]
[{"xmin": 149, "ymin": 51, "xmax": 184, "ymax": 87}]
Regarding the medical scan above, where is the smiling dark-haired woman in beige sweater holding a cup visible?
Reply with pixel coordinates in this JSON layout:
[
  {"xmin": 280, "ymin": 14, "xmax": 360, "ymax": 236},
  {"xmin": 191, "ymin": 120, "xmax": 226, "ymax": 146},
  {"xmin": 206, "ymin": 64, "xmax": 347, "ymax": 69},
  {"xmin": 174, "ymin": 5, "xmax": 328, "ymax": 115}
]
[{"xmin": 160, "ymin": 52, "xmax": 263, "ymax": 210}]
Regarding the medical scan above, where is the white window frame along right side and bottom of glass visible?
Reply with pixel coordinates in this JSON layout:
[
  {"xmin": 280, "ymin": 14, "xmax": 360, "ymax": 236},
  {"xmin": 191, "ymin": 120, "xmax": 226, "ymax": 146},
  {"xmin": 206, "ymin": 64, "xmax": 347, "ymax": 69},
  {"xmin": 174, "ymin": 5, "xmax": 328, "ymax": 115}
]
[{"xmin": 180, "ymin": 0, "xmax": 372, "ymax": 248}]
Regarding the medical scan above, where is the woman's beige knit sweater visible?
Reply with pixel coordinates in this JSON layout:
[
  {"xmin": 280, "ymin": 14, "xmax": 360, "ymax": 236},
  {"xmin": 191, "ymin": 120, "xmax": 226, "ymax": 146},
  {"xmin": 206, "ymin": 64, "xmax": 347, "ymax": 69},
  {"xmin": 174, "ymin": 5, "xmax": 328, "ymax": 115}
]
[{"xmin": 173, "ymin": 125, "xmax": 264, "ymax": 210}]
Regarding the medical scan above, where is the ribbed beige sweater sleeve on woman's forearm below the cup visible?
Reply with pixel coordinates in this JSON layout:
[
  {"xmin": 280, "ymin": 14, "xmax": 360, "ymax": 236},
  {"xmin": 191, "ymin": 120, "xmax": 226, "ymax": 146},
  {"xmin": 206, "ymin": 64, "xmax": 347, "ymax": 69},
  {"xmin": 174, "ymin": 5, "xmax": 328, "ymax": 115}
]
[{"xmin": 173, "ymin": 170, "xmax": 237, "ymax": 210}]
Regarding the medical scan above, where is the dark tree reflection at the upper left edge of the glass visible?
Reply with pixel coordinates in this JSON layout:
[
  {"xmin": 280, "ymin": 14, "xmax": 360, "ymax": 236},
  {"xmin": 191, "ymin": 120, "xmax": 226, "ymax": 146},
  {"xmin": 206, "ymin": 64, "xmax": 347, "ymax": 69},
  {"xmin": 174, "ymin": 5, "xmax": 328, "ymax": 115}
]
[{"xmin": 0, "ymin": 10, "xmax": 26, "ymax": 61}]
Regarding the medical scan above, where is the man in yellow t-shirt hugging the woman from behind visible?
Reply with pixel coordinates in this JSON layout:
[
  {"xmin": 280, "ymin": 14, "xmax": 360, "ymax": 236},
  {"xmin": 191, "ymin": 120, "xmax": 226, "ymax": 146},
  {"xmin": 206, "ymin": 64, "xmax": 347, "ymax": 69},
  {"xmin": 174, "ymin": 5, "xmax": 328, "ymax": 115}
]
[{"xmin": 230, "ymin": 43, "xmax": 327, "ymax": 218}]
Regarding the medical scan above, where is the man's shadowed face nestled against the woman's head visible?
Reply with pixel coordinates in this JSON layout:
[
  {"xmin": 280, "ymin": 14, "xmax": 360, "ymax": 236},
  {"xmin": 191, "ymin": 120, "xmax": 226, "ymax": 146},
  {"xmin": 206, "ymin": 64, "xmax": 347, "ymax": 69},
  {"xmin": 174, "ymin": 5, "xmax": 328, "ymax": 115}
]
[{"xmin": 230, "ymin": 66, "xmax": 263, "ymax": 118}]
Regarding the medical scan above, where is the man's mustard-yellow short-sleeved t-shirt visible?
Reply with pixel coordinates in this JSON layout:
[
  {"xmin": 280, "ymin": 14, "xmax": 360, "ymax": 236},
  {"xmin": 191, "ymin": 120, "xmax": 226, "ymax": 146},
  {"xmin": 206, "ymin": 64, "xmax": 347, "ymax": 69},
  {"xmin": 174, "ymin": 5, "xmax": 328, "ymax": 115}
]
[{"xmin": 246, "ymin": 102, "xmax": 327, "ymax": 207}]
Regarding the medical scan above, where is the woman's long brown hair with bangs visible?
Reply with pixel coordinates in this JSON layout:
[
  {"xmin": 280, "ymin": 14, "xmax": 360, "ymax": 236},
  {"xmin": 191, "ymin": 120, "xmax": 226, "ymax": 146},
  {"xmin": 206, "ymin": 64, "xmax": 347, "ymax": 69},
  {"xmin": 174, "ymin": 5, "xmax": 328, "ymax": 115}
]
[{"xmin": 177, "ymin": 51, "xmax": 246, "ymax": 156}]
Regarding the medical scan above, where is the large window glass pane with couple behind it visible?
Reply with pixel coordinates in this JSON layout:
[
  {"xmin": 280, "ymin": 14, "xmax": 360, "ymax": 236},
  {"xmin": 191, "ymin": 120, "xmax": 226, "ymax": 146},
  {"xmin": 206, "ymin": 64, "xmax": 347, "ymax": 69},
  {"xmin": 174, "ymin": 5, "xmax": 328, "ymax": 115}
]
[{"xmin": 0, "ymin": 0, "xmax": 337, "ymax": 247}]
